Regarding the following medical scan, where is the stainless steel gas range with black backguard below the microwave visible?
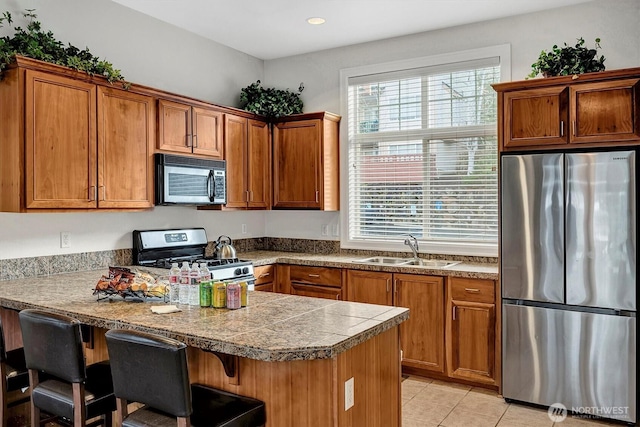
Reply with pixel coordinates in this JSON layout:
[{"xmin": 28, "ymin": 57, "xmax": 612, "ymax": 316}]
[{"xmin": 132, "ymin": 228, "xmax": 255, "ymax": 289}]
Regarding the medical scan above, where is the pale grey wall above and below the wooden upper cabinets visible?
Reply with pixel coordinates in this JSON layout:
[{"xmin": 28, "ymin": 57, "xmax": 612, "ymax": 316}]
[{"xmin": 0, "ymin": 0, "xmax": 640, "ymax": 259}]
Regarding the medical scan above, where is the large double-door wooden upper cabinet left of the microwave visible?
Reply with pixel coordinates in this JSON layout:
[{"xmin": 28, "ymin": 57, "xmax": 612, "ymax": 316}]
[{"xmin": 0, "ymin": 58, "xmax": 155, "ymax": 212}]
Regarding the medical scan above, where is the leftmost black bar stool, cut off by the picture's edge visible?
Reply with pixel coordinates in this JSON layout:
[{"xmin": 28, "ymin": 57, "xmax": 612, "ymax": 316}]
[{"xmin": 0, "ymin": 320, "xmax": 29, "ymax": 427}]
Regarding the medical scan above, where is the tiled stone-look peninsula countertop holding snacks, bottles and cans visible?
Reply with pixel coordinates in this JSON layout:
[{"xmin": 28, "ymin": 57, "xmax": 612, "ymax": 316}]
[{"xmin": 0, "ymin": 268, "xmax": 409, "ymax": 361}]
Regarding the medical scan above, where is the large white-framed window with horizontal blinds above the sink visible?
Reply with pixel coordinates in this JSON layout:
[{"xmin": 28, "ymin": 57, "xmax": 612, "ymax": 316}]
[{"xmin": 343, "ymin": 47, "xmax": 508, "ymax": 256}]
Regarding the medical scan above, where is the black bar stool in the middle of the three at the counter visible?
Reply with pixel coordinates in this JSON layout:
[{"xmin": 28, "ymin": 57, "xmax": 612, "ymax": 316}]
[{"xmin": 19, "ymin": 310, "xmax": 116, "ymax": 427}]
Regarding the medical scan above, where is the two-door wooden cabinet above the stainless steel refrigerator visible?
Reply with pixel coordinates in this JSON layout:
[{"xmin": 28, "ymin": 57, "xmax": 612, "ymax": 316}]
[{"xmin": 493, "ymin": 68, "xmax": 640, "ymax": 151}]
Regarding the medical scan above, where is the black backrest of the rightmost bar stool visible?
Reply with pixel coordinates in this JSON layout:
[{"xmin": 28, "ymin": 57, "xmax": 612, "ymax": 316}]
[{"xmin": 105, "ymin": 329, "xmax": 192, "ymax": 417}]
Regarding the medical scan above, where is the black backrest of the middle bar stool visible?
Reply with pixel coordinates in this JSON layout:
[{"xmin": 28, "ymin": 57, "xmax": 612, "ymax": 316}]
[{"xmin": 19, "ymin": 309, "xmax": 87, "ymax": 383}]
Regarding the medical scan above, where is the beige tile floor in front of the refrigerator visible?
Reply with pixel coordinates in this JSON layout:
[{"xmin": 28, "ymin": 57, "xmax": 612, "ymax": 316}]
[{"xmin": 402, "ymin": 377, "xmax": 621, "ymax": 427}]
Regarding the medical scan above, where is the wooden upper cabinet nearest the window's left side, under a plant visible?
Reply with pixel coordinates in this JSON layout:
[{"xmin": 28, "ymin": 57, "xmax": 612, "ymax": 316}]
[{"xmin": 273, "ymin": 112, "xmax": 340, "ymax": 211}]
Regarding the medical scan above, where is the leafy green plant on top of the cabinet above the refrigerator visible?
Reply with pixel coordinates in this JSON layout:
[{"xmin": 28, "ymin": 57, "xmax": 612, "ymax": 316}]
[{"xmin": 527, "ymin": 37, "xmax": 605, "ymax": 78}]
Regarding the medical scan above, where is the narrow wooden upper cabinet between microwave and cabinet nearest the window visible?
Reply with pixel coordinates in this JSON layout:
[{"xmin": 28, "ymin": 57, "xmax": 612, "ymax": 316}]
[{"xmin": 224, "ymin": 114, "xmax": 271, "ymax": 209}]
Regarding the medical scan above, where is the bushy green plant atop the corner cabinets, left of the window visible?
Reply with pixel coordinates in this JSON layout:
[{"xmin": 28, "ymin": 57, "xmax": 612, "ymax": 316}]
[{"xmin": 240, "ymin": 80, "xmax": 304, "ymax": 118}]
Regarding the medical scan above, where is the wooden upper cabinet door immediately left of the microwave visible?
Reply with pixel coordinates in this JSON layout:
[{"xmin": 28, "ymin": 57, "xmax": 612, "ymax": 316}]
[{"xmin": 97, "ymin": 86, "xmax": 155, "ymax": 208}]
